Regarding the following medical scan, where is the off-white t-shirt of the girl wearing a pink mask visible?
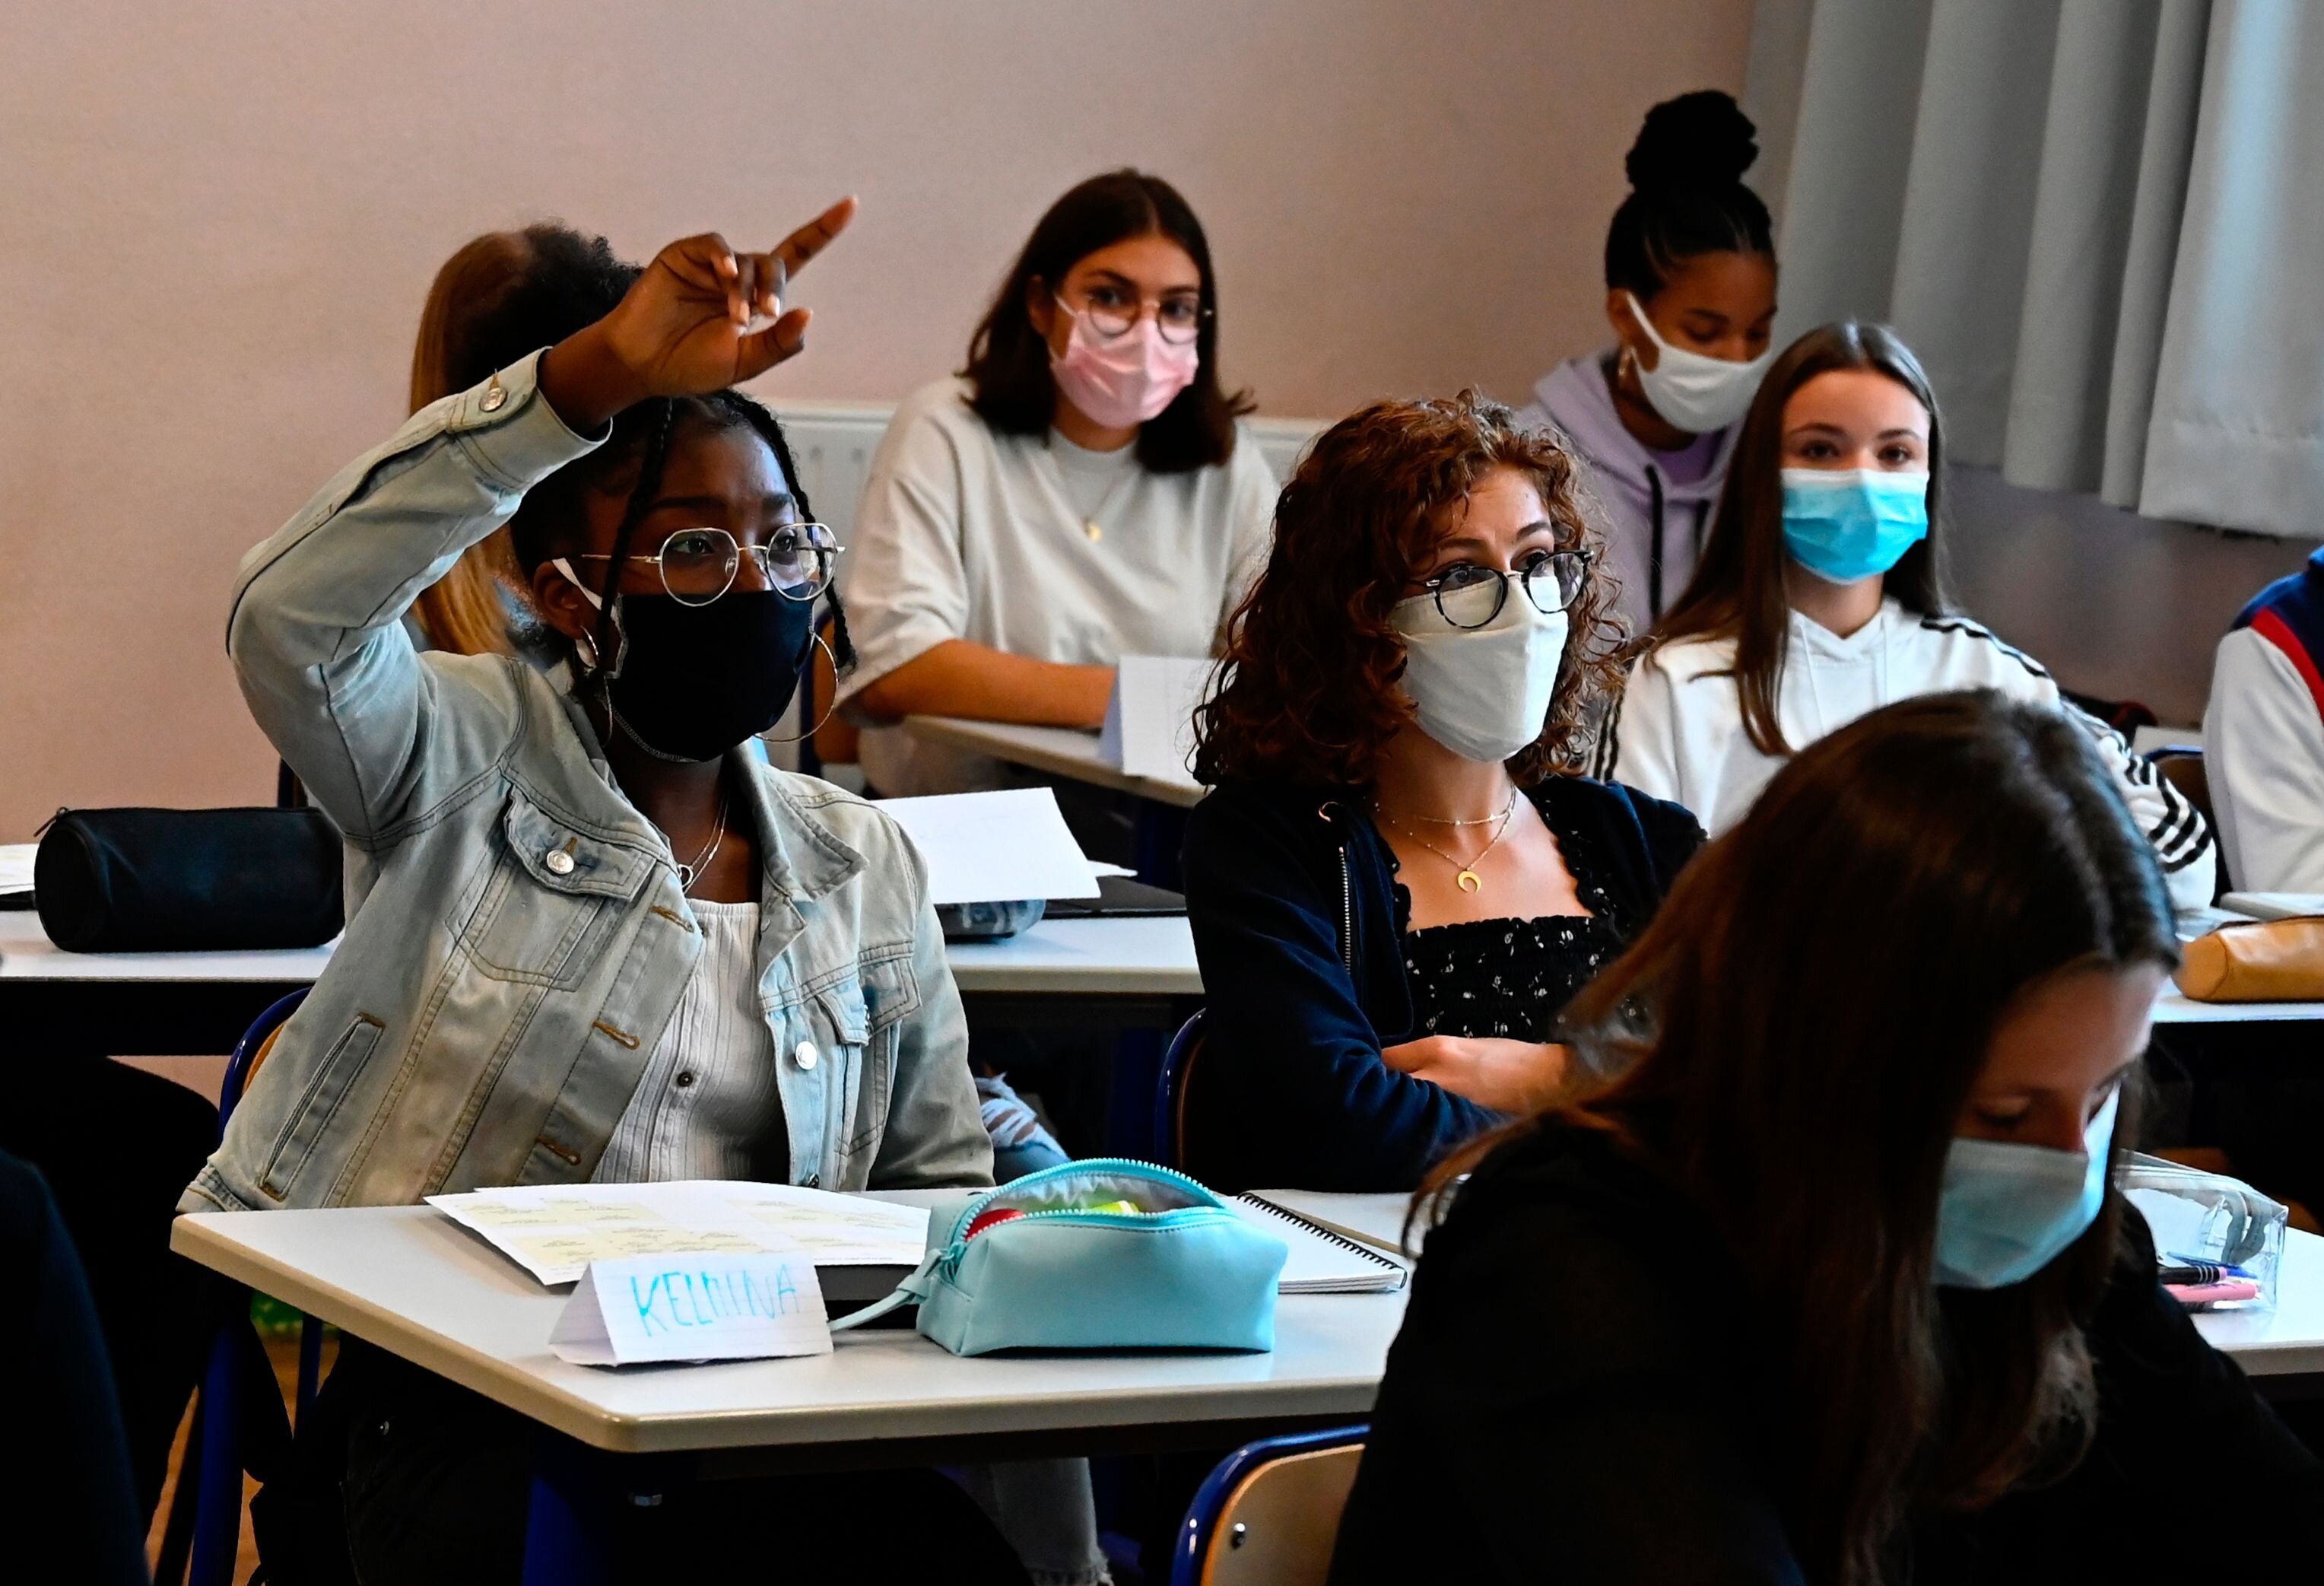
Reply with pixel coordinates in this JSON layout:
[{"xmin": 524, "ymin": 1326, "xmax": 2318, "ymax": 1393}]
[{"xmin": 839, "ymin": 379, "xmax": 1276, "ymax": 796}]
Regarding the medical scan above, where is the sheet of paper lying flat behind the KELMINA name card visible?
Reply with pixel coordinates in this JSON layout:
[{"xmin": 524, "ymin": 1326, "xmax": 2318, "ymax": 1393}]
[{"xmin": 427, "ymin": 1179, "xmax": 927, "ymax": 1286}]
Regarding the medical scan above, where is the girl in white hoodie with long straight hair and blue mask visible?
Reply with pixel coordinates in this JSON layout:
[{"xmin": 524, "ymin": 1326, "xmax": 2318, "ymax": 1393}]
[{"xmin": 1596, "ymin": 321, "xmax": 2217, "ymax": 907}]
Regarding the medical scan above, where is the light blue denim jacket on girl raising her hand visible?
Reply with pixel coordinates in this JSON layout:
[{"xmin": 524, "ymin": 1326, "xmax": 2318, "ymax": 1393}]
[{"xmin": 181, "ymin": 356, "xmax": 992, "ymax": 1212}]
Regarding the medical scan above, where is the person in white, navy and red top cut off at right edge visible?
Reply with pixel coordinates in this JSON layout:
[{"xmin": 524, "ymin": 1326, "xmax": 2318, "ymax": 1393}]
[{"xmin": 2203, "ymin": 548, "xmax": 2324, "ymax": 893}]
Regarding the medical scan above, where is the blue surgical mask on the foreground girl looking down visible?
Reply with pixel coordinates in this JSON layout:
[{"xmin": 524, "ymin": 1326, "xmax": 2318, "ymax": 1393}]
[{"xmin": 1936, "ymin": 1091, "xmax": 2122, "ymax": 1289}]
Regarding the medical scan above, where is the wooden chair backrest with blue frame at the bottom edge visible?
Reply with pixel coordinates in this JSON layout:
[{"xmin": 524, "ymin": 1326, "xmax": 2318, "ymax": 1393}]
[{"xmin": 1169, "ymin": 1425, "xmax": 1369, "ymax": 1586}]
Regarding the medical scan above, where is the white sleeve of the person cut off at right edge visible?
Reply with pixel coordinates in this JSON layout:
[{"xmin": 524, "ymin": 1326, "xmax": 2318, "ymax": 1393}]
[{"xmin": 2203, "ymin": 628, "xmax": 2324, "ymax": 893}]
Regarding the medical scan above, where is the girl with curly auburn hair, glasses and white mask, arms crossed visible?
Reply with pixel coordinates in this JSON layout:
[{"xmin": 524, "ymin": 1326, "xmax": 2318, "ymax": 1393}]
[{"xmin": 1186, "ymin": 396, "xmax": 1701, "ymax": 1190}]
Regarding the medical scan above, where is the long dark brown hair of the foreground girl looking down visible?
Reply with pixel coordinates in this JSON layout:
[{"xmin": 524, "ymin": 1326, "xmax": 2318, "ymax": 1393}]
[{"xmin": 1431, "ymin": 691, "xmax": 2177, "ymax": 1586}]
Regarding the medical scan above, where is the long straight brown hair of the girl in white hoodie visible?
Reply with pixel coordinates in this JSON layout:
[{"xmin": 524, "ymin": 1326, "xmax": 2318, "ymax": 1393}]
[{"xmin": 1648, "ymin": 319, "xmax": 1957, "ymax": 756}]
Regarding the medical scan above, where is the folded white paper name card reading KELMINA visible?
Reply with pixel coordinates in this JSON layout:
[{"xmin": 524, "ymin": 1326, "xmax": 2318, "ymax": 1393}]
[{"xmin": 548, "ymin": 1251, "xmax": 832, "ymax": 1365}]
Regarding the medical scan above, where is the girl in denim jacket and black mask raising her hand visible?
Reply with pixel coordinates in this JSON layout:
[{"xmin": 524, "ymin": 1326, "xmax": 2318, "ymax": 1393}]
[{"xmin": 181, "ymin": 200, "xmax": 1046, "ymax": 1581}]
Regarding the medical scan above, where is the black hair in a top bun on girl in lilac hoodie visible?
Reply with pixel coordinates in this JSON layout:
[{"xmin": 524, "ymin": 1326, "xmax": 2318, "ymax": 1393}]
[{"xmin": 1606, "ymin": 88, "xmax": 1776, "ymax": 302}]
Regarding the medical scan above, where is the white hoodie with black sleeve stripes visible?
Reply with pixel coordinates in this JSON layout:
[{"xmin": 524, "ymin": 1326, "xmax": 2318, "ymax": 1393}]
[{"xmin": 1596, "ymin": 600, "xmax": 2217, "ymax": 909}]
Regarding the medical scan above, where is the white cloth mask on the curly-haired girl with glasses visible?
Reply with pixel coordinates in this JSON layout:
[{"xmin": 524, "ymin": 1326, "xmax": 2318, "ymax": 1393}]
[{"xmin": 1389, "ymin": 579, "xmax": 1567, "ymax": 763}]
